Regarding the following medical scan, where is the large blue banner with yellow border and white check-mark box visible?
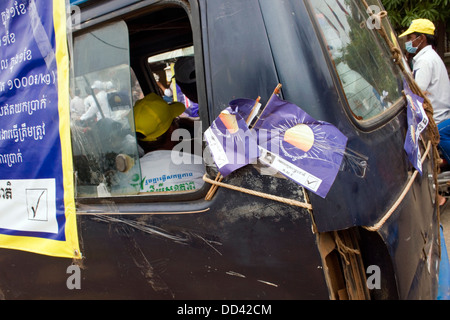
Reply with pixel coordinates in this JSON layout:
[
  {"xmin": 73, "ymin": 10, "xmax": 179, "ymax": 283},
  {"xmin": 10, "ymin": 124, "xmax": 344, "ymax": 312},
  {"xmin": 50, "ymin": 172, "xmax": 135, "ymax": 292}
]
[{"xmin": 0, "ymin": 0, "xmax": 81, "ymax": 258}]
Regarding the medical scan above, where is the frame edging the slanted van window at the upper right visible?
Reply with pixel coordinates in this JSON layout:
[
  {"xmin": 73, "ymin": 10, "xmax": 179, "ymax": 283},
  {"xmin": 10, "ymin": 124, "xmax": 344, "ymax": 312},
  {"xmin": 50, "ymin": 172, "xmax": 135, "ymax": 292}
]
[{"xmin": 303, "ymin": 0, "xmax": 406, "ymax": 132}]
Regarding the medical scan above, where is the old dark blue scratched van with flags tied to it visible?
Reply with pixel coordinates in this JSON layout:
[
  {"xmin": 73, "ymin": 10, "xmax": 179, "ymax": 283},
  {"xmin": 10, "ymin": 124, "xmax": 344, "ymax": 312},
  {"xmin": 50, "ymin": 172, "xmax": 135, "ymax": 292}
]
[{"xmin": 0, "ymin": 0, "xmax": 441, "ymax": 300}]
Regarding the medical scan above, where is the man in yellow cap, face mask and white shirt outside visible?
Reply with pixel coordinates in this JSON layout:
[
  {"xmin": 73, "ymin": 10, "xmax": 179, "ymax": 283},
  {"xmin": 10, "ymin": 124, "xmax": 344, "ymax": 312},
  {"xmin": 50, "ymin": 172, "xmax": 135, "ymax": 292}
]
[{"xmin": 399, "ymin": 19, "xmax": 450, "ymax": 172}]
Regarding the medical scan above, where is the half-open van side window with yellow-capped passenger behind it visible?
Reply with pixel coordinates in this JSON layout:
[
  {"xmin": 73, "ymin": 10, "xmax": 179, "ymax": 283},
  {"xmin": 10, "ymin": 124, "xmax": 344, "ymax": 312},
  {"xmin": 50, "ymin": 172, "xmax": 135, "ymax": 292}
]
[{"xmin": 71, "ymin": 6, "xmax": 205, "ymax": 201}]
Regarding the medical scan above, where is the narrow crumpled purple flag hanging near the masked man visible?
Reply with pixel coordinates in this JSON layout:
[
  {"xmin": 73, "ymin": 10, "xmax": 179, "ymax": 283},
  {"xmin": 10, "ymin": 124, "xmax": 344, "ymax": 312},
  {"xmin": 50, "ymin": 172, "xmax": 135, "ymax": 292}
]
[{"xmin": 404, "ymin": 81, "xmax": 428, "ymax": 175}]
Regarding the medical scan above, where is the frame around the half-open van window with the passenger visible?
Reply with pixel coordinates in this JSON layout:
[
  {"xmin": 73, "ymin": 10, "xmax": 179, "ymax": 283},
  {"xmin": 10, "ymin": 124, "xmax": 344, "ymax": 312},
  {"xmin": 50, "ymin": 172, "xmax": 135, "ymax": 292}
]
[{"xmin": 72, "ymin": 0, "xmax": 210, "ymax": 213}]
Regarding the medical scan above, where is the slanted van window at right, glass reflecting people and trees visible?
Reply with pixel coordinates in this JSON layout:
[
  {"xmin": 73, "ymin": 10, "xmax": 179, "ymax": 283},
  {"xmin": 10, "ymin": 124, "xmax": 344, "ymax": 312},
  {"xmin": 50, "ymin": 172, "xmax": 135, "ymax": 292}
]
[{"xmin": 311, "ymin": 0, "xmax": 402, "ymax": 121}]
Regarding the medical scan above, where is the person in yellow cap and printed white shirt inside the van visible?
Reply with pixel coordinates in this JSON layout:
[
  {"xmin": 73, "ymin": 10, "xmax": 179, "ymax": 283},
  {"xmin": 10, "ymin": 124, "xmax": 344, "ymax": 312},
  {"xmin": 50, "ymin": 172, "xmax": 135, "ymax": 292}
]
[{"xmin": 134, "ymin": 93, "xmax": 205, "ymax": 192}]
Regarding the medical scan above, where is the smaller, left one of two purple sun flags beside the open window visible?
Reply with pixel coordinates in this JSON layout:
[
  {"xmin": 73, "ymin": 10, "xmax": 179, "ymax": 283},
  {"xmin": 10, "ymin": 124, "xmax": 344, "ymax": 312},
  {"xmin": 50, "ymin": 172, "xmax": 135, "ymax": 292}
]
[{"xmin": 205, "ymin": 104, "xmax": 259, "ymax": 177}]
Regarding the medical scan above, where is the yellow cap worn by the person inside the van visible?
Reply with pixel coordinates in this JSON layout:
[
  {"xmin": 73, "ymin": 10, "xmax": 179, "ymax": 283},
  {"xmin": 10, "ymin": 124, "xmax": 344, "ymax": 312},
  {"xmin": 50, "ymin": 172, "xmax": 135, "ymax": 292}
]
[{"xmin": 134, "ymin": 93, "xmax": 186, "ymax": 141}]
